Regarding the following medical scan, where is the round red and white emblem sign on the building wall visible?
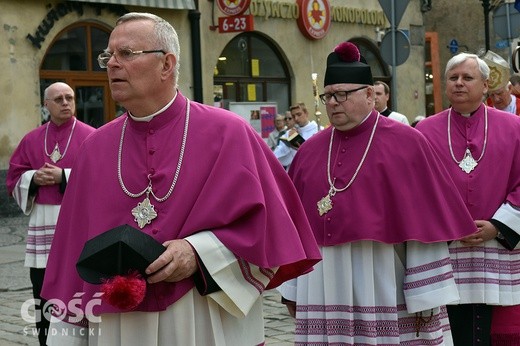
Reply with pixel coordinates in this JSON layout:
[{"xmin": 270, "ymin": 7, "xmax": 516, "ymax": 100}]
[{"xmin": 297, "ymin": 0, "xmax": 331, "ymax": 40}]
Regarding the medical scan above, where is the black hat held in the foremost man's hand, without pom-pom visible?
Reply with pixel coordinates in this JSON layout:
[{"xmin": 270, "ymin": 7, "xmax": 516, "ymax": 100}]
[{"xmin": 76, "ymin": 225, "xmax": 166, "ymax": 284}]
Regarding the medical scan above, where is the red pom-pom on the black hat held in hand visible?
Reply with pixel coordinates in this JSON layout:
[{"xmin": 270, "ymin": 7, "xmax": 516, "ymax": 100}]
[{"xmin": 101, "ymin": 271, "xmax": 146, "ymax": 310}]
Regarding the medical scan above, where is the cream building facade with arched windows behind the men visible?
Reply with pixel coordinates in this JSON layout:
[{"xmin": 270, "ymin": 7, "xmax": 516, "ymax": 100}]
[{"xmin": 0, "ymin": 0, "xmax": 426, "ymax": 171}]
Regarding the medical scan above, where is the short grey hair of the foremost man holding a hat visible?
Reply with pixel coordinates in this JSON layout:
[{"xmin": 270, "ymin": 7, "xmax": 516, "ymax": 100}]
[{"xmin": 116, "ymin": 12, "xmax": 181, "ymax": 85}]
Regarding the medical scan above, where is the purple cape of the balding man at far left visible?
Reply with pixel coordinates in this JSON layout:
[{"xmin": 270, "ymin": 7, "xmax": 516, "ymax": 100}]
[{"xmin": 6, "ymin": 117, "xmax": 95, "ymax": 205}]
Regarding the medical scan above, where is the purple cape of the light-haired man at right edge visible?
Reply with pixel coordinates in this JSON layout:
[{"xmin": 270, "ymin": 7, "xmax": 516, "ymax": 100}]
[{"xmin": 417, "ymin": 104, "xmax": 520, "ymax": 216}]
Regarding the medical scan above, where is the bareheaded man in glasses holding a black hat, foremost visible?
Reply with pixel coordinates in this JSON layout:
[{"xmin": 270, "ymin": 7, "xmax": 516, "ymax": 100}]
[{"xmin": 42, "ymin": 12, "xmax": 320, "ymax": 346}]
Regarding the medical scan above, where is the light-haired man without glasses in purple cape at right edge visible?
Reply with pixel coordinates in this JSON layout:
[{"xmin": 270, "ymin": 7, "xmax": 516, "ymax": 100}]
[{"xmin": 416, "ymin": 53, "xmax": 520, "ymax": 346}]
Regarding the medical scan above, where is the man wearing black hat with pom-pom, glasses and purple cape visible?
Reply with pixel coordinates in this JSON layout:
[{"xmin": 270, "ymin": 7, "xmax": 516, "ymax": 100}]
[{"xmin": 280, "ymin": 42, "xmax": 477, "ymax": 346}]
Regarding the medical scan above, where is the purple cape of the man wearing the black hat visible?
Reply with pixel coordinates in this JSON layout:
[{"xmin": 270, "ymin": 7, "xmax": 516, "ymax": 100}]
[{"xmin": 289, "ymin": 111, "xmax": 477, "ymax": 246}]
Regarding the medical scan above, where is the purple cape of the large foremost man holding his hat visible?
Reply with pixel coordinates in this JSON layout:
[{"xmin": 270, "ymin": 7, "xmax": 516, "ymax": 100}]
[{"xmin": 43, "ymin": 93, "xmax": 321, "ymax": 313}]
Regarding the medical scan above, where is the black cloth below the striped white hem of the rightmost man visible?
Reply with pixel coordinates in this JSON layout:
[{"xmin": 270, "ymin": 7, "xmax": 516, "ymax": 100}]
[{"xmin": 447, "ymin": 304, "xmax": 492, "ymax": 346}]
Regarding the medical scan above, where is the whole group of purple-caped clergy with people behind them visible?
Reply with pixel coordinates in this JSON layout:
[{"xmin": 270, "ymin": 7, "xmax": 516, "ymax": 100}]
[{"xmin": 7, "ymin": 12, "xmax": 520, "ymax": 346}]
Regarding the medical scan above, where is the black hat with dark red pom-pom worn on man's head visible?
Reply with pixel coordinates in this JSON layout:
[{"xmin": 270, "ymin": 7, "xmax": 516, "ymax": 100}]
[{"xmin": 324, "ymin": 42, "xmax": 374, "ymax": 86}]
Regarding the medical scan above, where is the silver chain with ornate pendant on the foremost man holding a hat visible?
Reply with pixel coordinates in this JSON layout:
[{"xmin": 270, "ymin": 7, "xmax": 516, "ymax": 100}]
[{"xmin": 117, "ymin": 98, "xmax": 190, "ymax": 228}]
